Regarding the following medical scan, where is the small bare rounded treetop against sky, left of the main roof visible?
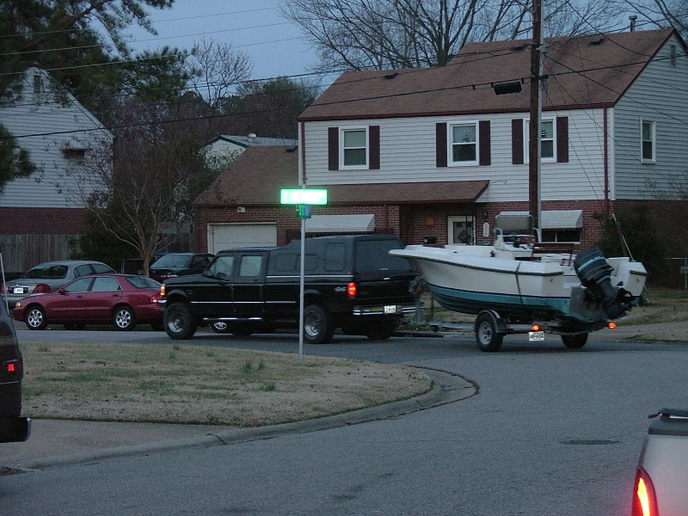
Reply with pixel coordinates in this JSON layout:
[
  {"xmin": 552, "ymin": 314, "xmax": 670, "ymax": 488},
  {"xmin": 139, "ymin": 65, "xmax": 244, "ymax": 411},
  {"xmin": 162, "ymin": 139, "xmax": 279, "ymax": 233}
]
[{"xmin": 188, "ymin": 40, "xmax": 253, "ymax": 108}]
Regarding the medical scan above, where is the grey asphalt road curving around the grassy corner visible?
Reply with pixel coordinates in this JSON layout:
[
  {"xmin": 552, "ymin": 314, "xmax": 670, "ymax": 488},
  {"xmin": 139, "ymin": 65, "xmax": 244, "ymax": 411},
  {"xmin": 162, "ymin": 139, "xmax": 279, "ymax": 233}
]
[{"xmin": 0, "ymin": 330, "xmax": 688, "ymax": 516}]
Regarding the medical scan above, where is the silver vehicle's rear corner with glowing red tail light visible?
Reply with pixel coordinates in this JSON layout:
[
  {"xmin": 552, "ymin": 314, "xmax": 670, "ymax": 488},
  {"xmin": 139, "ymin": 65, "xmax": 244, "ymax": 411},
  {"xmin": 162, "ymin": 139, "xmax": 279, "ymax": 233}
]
[{"xmin": 631, "ymin": 409, "xmax": 688, "ymax": 516}]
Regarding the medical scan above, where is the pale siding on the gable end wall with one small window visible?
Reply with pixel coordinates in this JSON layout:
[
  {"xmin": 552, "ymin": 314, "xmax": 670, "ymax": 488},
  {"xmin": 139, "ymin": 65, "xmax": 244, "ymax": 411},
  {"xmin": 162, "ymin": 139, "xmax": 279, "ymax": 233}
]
[{"xmin": 613, "ymin": 37, "xmax": 688, "ymax": 200}]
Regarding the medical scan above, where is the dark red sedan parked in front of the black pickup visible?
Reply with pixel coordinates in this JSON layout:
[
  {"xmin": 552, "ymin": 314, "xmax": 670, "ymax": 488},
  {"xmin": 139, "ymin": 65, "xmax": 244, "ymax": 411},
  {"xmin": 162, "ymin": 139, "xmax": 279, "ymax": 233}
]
[{"xmin": 12, "ymin": 274, "xmax": 162, "ymax": 330}]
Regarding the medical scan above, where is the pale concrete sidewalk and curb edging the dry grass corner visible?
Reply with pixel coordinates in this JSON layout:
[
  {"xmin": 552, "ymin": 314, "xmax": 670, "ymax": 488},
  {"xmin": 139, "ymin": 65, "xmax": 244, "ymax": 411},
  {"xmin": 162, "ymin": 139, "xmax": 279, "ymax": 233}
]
[{"xmin": 0, "ymin": 369, "xmax": 476, "ymax": 475}]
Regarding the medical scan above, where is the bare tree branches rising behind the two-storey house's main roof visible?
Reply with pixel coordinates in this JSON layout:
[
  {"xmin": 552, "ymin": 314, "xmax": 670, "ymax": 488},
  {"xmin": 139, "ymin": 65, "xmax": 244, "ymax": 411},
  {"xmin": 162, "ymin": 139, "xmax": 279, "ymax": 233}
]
[{"xmin": 282, "ymin": 0, "xmax": 636, "ymax": 71}]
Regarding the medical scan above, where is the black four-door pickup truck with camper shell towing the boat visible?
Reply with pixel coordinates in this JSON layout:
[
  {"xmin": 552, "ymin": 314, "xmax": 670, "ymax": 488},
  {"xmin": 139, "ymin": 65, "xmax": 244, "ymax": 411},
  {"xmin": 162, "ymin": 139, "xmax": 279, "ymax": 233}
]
[{"xmin": 161, "ymin": 235, "xmax": 416, "ymax": 344}]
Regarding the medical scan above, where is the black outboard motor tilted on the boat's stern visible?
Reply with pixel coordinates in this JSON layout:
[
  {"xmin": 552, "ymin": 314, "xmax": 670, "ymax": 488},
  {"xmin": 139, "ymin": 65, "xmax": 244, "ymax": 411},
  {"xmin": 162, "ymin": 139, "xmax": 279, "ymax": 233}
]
[{"xmin": 573, "ymin": 247, "xmax": 631, "ymax": 319}]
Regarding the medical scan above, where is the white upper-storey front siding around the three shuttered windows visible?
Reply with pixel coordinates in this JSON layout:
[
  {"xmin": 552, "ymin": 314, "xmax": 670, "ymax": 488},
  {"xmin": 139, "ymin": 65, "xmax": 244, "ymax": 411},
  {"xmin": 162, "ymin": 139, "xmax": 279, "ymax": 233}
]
[{"xmin": 304, "ymin": 109, "xmax": 604, "ymax": 202}]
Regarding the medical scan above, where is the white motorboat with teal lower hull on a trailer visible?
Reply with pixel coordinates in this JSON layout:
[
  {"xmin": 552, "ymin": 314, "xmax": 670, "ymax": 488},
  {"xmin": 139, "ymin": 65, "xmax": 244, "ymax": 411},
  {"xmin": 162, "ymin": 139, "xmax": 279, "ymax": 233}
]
[{"xmin": 390, "ymin": 212, "xmax": 647, "ymax": 350}]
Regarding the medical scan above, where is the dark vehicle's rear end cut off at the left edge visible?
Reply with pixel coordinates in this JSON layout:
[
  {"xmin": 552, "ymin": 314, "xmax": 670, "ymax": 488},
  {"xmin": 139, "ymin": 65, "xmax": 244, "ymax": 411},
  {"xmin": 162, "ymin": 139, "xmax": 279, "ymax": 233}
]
[{"xmin": 0, "ymin": 292, "xmax": 31, "ymax": 443}]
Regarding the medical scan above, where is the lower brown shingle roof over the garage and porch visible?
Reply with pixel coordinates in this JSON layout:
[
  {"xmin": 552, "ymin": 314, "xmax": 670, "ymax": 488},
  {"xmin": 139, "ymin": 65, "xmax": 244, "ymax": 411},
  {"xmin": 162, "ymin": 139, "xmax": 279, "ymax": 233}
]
[{"xmin": 194, "ymin": 147, "xmax": 489, "ymax": 206}]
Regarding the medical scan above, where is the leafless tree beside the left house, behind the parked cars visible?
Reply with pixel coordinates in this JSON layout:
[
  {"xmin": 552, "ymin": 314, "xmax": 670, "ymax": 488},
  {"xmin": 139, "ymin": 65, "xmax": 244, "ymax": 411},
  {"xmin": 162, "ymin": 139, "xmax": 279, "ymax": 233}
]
[{"xmin": 65, "ymin": 100, "xmax": 212, "ymax": 271}]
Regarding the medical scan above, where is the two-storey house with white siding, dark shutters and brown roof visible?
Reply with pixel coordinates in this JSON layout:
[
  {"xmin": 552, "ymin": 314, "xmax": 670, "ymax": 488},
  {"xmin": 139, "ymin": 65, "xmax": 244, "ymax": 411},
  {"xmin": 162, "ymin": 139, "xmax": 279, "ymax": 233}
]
[{"xmin": 192, "ymin": 29, "xmax": 688, "ymax": 260}]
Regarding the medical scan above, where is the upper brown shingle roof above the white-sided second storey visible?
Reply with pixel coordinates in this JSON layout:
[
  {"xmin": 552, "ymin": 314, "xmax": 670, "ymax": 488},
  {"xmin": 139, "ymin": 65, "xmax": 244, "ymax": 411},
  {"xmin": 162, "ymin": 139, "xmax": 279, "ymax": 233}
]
[{"xmin": 299, "ymin": 29, "xmax": 678, "ymax": 120}]
